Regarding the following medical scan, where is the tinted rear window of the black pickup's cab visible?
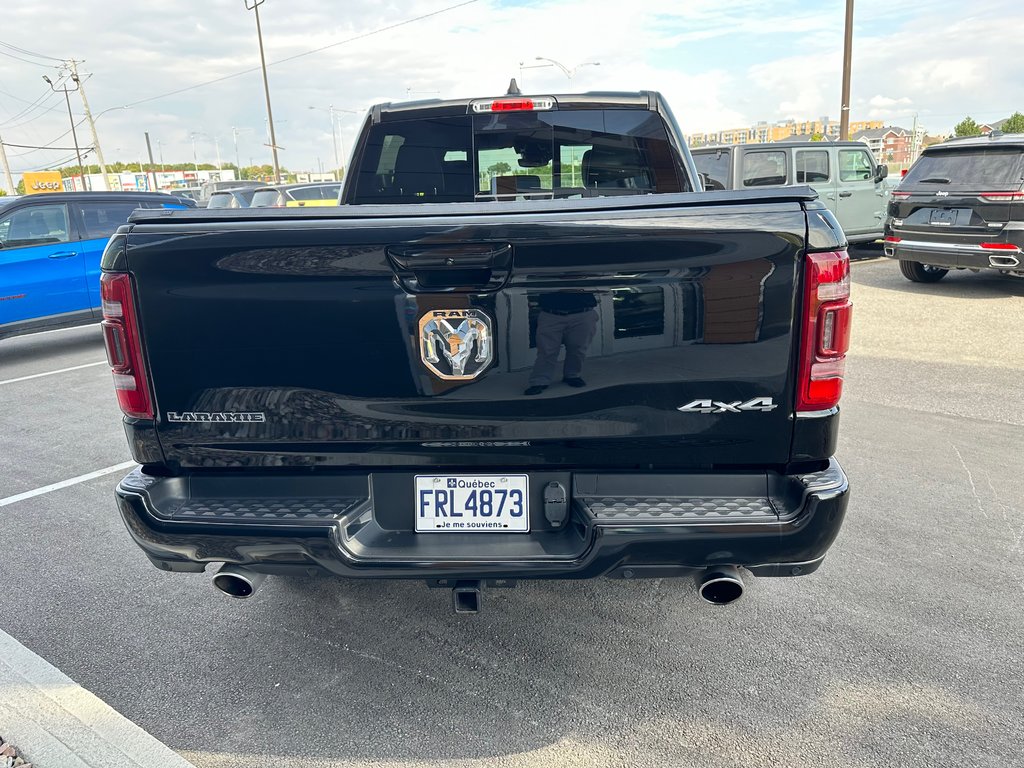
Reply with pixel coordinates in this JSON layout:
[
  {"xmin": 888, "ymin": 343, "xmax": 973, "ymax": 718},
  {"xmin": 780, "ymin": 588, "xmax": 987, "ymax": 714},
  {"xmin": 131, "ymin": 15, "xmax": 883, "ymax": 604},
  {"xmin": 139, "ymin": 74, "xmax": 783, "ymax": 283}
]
[{"xmin": 353, "ymin": 110, "xmax": 688, "ymax": 203}]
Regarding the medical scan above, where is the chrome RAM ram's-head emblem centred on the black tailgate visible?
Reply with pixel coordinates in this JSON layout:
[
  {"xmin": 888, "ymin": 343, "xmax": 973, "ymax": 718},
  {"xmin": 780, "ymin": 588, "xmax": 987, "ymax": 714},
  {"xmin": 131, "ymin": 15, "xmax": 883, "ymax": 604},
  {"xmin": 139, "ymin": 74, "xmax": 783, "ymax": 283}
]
[{"xmin": 420, "ymin": 309, "xmax": 494, "ymax": 381}]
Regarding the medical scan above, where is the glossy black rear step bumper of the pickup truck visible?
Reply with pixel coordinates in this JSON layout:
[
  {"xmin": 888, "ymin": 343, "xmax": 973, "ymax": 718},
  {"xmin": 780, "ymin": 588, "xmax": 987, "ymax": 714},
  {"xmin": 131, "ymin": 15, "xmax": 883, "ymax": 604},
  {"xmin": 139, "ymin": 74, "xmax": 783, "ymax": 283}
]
[{"xmin": 116, "ymin": 460, "xmax": 849, "ymax": 581}]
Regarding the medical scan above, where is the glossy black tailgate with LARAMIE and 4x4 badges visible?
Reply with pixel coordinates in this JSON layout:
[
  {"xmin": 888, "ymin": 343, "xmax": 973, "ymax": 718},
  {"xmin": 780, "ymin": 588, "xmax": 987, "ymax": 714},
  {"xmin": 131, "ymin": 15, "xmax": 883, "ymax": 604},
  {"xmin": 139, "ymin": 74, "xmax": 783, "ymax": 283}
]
[{"xmin": 127, "ymin": 196, "xmax": 807, "ymax": 469}]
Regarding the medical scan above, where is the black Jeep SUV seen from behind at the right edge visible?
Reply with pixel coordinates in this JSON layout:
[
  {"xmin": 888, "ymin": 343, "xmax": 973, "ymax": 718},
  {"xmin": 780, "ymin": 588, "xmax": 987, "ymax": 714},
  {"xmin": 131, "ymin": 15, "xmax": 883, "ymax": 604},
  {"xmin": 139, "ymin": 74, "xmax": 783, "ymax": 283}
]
[{"xmin": 885, "ymin": 133, "xmax": 1024, "ymax": 283}]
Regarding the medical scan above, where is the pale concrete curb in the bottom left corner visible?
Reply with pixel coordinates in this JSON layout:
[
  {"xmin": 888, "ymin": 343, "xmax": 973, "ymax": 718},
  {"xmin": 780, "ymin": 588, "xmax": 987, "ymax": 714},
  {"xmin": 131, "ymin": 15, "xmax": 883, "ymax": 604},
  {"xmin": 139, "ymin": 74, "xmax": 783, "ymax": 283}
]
[{"xmin": 0, "ymin": 631, "xmax": 195, "ymax": 768}]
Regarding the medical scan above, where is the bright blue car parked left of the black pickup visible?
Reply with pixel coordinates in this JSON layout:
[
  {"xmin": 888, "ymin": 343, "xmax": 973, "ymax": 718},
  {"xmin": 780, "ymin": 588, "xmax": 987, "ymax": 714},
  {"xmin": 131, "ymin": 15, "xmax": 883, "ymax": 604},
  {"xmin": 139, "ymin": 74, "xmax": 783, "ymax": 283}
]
[{"xmin": 0, "ymin": 193, "xmax": 196, "ymax": 339}]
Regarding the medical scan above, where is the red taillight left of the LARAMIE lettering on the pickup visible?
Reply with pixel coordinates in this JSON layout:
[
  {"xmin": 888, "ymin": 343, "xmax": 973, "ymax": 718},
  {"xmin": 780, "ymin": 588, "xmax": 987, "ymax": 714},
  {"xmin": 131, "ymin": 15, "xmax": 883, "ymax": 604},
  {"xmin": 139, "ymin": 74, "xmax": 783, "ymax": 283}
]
[{"xmin": 99, "ymin": 272, "xmax": 154, "ymax": 419}]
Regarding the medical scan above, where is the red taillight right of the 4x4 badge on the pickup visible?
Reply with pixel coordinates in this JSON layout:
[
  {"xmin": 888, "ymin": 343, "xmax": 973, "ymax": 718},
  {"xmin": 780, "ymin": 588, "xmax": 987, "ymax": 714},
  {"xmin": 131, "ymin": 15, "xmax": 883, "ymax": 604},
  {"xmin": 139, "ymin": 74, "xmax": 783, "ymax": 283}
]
[{"xmin": 797, "ymin": 251, "xmax": 853, "ymax": 411}]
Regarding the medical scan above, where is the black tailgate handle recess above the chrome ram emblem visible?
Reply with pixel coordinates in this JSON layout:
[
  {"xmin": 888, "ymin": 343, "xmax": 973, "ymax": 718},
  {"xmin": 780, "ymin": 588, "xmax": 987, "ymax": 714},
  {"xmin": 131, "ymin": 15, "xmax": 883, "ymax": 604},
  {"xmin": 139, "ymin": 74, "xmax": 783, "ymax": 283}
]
[{"xmin": 385, "ymin": 243, "xmax": 512, "ymax": 293}]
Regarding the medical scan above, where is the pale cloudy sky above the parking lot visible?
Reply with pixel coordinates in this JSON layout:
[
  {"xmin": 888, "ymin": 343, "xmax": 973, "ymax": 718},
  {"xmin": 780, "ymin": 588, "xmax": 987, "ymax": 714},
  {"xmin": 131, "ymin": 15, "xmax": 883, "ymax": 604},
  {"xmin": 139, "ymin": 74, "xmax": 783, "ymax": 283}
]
[{"xmin": 0, "ymin": 0, "xmax": 1024, "ymax": 181}]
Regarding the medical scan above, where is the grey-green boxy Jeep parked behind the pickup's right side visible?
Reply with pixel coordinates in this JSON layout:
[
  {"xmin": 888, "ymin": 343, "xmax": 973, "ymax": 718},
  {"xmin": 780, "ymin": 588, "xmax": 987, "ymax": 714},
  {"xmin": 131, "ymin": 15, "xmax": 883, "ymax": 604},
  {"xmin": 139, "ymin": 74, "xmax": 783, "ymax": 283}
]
[{"xmin": 692, "ymin": 141, "xmax": 890, "ymax": 243}]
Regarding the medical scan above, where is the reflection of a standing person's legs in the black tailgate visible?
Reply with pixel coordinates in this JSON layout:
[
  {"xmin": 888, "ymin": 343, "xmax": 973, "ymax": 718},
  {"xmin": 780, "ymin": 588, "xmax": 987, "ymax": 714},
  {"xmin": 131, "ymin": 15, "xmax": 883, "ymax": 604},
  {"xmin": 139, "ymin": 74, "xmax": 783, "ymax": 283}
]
[{"xmin": 525, "ymin": 291, "xmax": 597, "ymax": 394}]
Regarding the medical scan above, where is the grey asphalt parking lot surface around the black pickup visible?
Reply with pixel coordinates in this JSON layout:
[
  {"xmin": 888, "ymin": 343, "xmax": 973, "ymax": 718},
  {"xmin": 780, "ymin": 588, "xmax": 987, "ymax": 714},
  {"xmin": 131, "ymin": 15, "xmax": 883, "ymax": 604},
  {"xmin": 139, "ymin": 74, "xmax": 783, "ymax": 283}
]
[{"xmin": 0, "ymin": 259, "xmax": 1024, "ymax": 768}]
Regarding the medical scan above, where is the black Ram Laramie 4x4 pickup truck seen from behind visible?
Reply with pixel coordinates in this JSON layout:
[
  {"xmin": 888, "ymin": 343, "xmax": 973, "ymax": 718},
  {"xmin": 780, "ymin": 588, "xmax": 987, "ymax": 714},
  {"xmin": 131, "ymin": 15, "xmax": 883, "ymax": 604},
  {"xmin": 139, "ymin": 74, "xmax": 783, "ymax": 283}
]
[{"xmin": 102, "ymin": 85, "xmax": 851, "ymax": 611}]
